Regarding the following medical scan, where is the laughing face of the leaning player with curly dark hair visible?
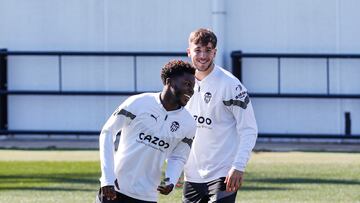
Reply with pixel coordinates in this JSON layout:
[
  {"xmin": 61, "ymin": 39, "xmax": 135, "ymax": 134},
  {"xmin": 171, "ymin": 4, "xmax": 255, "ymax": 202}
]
[{"xmin": 171, "ymin": 73, "xmax": 195, "ymax": 106}]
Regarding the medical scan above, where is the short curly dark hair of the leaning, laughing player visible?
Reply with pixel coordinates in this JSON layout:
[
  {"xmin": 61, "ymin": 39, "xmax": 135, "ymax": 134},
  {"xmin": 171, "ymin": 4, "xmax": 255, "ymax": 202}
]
[{"xmin": 161, "ymin": 60, "xmax": 195, "ymax": 85}]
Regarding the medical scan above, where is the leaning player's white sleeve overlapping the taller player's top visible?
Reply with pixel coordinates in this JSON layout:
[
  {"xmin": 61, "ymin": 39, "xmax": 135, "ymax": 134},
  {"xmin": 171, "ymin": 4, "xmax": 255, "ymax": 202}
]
[{"xmin": 165, "ymin": 123, "xmax": 196, "ymax": 185}]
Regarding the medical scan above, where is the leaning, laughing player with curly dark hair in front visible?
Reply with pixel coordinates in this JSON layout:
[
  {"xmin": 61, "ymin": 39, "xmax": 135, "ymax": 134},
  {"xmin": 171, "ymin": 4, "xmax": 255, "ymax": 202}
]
[{"xmin": 96, "ymin": 60, "xmax": 196, "ymax": 203}]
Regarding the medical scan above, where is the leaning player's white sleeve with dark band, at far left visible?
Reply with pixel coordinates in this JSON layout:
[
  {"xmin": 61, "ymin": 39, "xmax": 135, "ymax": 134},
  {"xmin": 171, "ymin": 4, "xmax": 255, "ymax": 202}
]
[{"xmin": 99, "ymin": 100, "xmax": 135, "ymax": 187}]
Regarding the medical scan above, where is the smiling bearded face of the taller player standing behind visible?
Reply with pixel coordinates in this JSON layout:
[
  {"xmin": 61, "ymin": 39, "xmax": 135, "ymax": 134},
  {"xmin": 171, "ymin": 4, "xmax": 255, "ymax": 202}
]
[{"xmin": 187, "ymin": 42, "xmax": 216, "ymax": 73}]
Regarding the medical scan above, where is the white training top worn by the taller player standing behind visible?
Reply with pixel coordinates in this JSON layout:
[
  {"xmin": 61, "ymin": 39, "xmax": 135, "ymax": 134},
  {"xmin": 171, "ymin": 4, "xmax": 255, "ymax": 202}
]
[{"xmin": 184, "ymin": 66, "xmax": 257, "ymax": 183}]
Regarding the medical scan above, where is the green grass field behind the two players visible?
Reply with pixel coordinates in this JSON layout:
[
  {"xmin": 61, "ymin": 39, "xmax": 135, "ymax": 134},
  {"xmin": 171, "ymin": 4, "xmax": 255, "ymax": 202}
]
[{"xmin": 0, "ymin": 150, "xmax": 360, "ymax": 203}]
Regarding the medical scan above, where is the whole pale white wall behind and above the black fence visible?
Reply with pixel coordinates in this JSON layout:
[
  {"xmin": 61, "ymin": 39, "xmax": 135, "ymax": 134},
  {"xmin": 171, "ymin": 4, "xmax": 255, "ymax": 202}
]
[{"xmin": 0, "ymin": 0, "xmax": 360, "ymax": 134}]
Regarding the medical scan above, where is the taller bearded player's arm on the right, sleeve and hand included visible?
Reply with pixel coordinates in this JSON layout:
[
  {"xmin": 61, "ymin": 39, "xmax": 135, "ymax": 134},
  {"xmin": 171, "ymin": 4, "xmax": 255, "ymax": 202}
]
[{"xmin": 224, "ymin": 84, "xmax": 257, "ymax": 191}]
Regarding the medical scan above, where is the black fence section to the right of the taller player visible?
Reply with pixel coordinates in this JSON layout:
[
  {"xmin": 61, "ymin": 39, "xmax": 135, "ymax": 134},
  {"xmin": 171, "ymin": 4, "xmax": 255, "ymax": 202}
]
[{"xmin": 231, "ymin": 51, "xmax": 360, "ymax": 139}]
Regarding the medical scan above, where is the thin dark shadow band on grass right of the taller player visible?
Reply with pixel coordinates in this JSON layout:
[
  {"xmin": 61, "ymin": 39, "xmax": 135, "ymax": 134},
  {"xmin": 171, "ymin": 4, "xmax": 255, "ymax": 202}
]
[{"xmin": 249, "ymin": 178, "xmax": 360, "ymax": 185}]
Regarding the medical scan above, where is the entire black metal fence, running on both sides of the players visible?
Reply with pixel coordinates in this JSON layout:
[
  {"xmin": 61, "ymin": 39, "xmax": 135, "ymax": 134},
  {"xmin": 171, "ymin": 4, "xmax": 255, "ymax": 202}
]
[{"xmin": 0, "ymin": 49, "xmax": 360, "ymax": 139}]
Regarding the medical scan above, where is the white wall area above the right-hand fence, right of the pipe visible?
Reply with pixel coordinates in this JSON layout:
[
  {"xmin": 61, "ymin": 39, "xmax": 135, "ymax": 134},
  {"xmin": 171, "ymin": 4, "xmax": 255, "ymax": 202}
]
[{"xmin": 226, "ymin": 0, "xmax": 360, "ymax": 53}]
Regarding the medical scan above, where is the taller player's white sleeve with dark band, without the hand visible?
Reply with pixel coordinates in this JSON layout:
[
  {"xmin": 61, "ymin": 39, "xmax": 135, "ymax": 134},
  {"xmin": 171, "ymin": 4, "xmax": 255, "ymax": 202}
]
[{"xmin": 224, "ymin": 82, "xmax": 258, "ymax": 172}]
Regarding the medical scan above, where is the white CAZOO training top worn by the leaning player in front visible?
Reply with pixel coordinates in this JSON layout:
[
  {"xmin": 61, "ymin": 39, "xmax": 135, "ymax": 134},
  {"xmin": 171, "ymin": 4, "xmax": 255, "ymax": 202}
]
[{"xmin": 99, "ymin": 93, "xmax": 196, "ymax": 201}]
